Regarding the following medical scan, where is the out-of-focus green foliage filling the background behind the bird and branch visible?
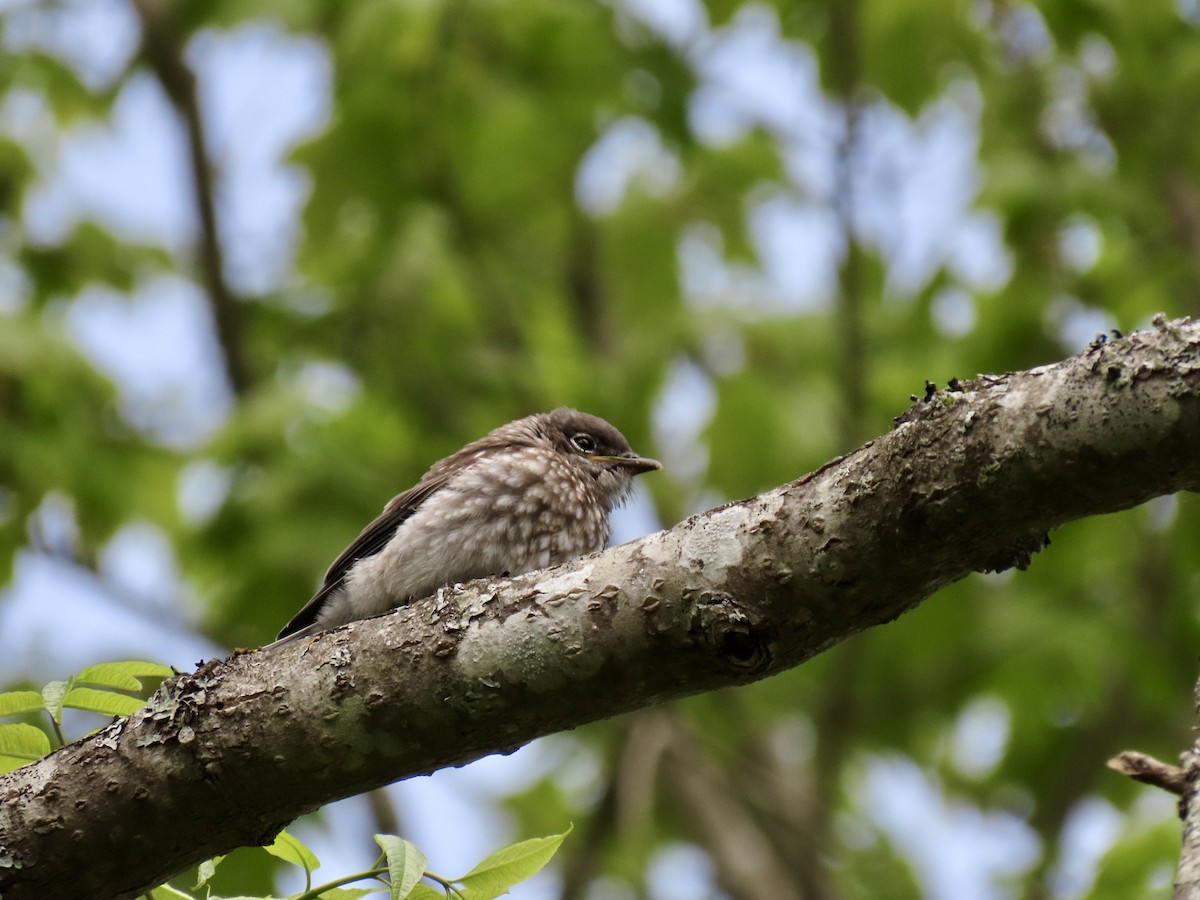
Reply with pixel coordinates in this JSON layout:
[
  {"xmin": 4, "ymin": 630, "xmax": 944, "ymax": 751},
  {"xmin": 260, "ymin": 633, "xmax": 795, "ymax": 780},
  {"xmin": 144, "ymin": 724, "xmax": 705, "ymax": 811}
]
[{"xmin": 0, "ymin": 0, "xmax": 1200, "ymax": 898}]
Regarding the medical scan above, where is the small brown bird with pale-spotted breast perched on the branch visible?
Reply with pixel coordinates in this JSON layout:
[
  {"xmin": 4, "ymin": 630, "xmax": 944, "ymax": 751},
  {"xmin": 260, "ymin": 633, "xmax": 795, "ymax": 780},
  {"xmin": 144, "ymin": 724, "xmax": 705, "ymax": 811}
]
[{"xmin": 270, "ymin": 407, "xmax": 662, "ymax": 647}]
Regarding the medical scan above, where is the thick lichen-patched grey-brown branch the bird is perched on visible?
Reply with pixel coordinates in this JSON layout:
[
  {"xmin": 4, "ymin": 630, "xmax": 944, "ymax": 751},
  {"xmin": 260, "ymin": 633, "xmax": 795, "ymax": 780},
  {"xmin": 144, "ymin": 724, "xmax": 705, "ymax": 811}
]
[{"xmin": 0, "ymin": 319, "xmax": 1200, "ymax": 900}]
